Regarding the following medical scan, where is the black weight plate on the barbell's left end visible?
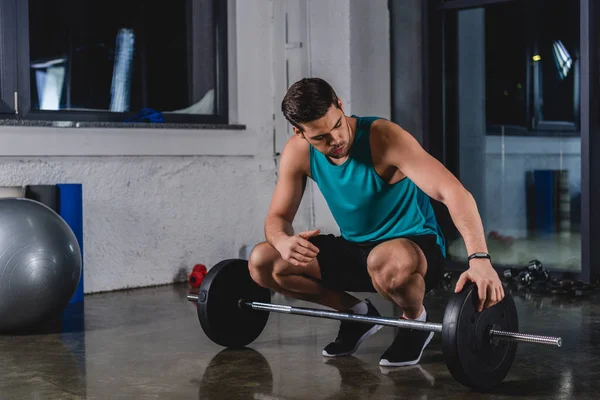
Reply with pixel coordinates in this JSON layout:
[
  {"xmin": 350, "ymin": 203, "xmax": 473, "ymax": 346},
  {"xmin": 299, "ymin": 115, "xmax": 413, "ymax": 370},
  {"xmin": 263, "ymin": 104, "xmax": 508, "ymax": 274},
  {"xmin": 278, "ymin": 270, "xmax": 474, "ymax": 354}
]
[{"xmin": 197, "ymin": 259, "xmax": 271, "ymax": 348}]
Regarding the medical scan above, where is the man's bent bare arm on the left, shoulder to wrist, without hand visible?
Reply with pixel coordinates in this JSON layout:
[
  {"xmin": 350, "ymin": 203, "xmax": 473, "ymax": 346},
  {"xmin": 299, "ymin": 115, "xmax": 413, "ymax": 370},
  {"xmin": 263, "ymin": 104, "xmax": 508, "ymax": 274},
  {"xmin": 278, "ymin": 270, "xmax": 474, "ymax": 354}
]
[{"xmin": 265, "ymin": 137, "xmax": 308, "ymax": 247}]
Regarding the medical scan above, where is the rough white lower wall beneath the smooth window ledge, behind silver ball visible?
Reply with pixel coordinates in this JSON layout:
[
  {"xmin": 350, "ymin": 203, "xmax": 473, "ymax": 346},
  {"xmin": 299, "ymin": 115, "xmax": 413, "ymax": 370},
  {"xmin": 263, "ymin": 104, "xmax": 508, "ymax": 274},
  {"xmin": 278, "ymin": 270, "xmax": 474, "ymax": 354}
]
[{"xmin": 0, "ymin": 156, "xmax": 273, "ymax": 293}]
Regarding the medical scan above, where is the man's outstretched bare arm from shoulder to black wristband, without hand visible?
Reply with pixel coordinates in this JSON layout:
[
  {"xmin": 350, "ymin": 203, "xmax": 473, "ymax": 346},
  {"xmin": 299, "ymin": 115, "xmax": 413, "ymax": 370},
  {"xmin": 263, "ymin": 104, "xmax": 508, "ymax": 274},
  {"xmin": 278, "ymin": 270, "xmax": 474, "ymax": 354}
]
[{"xmin": 375, "ymin": 121, "xmax": 487, "ymax": 254}]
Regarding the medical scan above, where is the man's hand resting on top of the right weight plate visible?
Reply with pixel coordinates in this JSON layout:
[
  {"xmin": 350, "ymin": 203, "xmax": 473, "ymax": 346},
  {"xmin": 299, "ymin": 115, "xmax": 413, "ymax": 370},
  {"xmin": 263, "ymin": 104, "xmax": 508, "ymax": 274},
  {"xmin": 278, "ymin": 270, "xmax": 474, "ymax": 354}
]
[{"xmin": 454, "ymin": 258, "xmax": 504, "ymax": 312}]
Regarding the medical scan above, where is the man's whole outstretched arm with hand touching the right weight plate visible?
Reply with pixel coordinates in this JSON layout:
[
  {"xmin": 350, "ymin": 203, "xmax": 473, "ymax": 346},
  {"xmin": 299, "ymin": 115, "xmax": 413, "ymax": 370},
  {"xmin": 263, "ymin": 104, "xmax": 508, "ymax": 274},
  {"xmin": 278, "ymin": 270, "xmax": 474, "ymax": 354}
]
[{"xmin": 375, "ymin": 121, "xmax": 504, "ymax": 310}]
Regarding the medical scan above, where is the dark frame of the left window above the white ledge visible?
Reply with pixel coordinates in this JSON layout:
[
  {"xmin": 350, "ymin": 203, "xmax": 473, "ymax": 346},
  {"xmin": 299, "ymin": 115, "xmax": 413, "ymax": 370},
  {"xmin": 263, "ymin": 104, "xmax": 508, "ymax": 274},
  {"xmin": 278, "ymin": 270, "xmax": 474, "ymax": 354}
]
[{"xmin": 0, "ymin": 0, "xmax": 229, "ymax": 125}]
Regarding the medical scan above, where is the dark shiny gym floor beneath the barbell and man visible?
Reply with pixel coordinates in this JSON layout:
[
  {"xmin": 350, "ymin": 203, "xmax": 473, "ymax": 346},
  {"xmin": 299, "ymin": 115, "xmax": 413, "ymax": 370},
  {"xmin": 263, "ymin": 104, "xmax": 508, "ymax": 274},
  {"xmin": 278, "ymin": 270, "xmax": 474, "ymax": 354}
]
[{"xmin": 0, "ymin": 278, "xmax": 600, "ymax": 399}]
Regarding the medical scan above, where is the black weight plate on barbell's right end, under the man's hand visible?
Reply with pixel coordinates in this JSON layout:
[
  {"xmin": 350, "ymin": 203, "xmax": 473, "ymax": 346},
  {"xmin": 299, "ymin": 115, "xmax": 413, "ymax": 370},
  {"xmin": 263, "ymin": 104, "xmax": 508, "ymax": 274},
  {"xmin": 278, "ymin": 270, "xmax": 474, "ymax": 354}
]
[{"xmin": 442, "ymin": 285, "xmax": 519, "ymax": 390}]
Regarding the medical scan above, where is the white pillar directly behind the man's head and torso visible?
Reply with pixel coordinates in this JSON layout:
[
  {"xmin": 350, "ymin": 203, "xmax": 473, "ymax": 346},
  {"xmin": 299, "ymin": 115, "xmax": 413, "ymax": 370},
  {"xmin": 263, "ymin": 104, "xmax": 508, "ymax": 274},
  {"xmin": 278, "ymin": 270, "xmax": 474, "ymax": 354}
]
[{"xmin": 309, "ymin": 0, "xmax": 391, "ymax": 234}]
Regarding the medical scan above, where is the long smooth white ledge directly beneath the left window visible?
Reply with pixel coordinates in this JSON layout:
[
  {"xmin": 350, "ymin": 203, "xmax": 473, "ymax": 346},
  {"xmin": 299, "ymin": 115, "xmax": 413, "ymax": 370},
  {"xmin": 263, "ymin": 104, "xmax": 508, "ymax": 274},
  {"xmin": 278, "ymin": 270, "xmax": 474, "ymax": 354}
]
[{"xmin": 0, "ymin": 119, "xmax": 256, "ymax": 157}]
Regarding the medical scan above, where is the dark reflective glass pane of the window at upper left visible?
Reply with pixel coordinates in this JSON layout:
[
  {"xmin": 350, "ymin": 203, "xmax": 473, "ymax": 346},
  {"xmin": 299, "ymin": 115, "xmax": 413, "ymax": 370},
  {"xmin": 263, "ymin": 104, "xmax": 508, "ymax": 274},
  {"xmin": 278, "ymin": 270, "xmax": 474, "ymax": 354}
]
[{"xmin": 29, "ymin": 0, "xmax": 215, "ymax": 114}]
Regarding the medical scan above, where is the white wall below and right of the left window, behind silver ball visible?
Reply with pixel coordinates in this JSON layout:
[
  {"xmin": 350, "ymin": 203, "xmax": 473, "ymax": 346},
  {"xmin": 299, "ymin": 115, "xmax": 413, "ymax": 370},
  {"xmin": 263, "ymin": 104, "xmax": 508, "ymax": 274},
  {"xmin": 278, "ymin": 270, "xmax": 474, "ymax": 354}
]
[{"xmin": 0, "ymin": 0, "xmax": 275, "ymax": 293}]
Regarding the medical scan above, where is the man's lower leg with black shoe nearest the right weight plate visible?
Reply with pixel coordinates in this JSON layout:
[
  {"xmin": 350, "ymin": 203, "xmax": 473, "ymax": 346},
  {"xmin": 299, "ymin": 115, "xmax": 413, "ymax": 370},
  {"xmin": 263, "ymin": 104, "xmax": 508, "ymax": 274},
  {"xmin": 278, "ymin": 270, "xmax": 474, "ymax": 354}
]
[{"xmin": 367, "ymin": 239, "xmax": 433, "ymax": 366}]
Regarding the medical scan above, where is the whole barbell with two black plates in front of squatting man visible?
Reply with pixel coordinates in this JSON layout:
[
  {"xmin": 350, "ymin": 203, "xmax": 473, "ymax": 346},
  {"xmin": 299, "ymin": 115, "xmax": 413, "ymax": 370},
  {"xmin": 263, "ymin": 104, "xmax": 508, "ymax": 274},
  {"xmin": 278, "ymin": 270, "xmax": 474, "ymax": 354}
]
[{"xmin": 187, "ymin": 259, "xmax": 562, "ymax": 390}]
